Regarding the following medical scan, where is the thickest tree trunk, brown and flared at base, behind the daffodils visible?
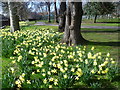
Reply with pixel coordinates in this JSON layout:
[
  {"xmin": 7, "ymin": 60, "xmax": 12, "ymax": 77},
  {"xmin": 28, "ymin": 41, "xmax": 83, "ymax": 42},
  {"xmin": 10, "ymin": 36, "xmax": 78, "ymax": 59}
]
[{"xmin": 62, "ymin": 2, "xmax": 86, "ymax": 46}]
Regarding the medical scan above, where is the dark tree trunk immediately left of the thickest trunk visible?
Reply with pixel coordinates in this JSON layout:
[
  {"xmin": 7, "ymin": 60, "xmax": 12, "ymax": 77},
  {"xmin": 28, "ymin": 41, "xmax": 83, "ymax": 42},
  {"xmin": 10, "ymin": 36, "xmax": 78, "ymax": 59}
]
[{"xmin": 58, "ymin": 1, "xmax": 66, "ymax": 32}]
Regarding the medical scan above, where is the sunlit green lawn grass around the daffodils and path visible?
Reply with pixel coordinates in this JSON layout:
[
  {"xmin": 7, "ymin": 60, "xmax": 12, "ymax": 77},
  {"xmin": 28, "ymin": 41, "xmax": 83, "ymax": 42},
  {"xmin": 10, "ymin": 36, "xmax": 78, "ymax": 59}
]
[{"xmin": 2, "ymin": 19, "xmax": 120, "ymax": 87}]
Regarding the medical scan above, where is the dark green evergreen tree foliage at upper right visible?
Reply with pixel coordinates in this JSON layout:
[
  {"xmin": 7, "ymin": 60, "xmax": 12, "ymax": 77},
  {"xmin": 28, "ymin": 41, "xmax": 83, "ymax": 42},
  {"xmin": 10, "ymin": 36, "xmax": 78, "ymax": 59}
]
[{"xmin": 83, "ymin": 2, "xmax": 115, "ymax": 15}]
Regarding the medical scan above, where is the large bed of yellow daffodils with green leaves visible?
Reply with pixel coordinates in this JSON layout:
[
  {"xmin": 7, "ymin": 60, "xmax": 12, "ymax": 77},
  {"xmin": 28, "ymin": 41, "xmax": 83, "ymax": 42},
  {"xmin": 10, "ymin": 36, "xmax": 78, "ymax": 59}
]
[{"xmin": 2, "ymin": 29, "xmax": 118, "ymax": 88}]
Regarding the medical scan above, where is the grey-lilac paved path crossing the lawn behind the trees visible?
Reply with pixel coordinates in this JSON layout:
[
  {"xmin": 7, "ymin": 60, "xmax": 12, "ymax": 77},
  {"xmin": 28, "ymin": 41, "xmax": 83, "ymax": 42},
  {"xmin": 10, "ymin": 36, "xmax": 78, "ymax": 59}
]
[{"xmin": 34, "ymin": 22, "xmax": 120, "ymax": 29}]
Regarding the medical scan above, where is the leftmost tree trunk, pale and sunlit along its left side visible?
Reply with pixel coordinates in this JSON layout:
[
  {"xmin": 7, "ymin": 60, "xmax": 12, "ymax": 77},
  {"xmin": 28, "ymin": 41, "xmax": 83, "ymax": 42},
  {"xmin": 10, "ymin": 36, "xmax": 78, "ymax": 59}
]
[{"xmin": 8, "ymin": 1, "xmax": 20, "ymax": 32}]
